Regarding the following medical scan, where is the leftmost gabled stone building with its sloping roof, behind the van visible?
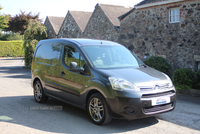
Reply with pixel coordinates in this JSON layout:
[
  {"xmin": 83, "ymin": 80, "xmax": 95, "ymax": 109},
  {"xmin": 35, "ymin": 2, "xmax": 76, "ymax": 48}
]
[{"xmin": 44, "ymin": 16, "xmax": 64, "ymax": 39}]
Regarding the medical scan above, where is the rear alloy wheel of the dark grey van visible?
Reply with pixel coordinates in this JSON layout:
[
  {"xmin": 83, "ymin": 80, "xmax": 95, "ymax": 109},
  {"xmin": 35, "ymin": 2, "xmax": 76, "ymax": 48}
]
[{"xmin": 34, "ymin": 81, "xmax": 49, "ymax": 103}]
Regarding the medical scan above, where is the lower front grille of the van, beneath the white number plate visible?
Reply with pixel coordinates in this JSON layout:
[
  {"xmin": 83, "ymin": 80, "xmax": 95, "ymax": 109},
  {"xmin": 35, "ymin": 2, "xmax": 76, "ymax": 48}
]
[{"xmin": 143, "ymin": 103, "xmax": 173, "ymax": 114}]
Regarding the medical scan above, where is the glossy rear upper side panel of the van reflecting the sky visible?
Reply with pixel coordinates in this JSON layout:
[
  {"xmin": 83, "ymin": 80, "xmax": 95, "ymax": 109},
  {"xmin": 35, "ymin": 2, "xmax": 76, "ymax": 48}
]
[{"xmin": 35, "ymin": 44, "xmax": 61, "ymax": 65}]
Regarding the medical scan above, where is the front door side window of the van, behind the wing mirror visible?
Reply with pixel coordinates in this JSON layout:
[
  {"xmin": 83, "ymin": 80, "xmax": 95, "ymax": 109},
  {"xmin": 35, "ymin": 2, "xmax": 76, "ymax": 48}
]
[{"xmin": 64, "ymin": 46, "xmax": 85, "ymax": 67}]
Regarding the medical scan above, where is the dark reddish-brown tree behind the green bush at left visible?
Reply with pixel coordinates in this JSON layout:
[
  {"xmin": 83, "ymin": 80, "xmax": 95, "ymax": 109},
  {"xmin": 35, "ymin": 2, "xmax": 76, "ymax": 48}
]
[{"xmin": 4, "ymin": 11, "xmax": 41, "ymax": 35}]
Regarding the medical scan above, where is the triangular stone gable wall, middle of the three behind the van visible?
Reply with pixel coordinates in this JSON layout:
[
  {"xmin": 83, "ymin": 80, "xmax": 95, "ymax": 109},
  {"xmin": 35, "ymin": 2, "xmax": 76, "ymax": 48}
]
[{"xmin": 58, "ymin": 12, "xmax": 82, "ymax": 38}]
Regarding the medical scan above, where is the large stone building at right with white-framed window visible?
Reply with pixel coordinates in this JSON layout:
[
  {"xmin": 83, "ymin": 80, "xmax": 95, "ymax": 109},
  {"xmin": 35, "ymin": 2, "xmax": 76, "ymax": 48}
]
[{"xmin": 119, "ymin": 0, "xmax": 200, "ymax": 71}]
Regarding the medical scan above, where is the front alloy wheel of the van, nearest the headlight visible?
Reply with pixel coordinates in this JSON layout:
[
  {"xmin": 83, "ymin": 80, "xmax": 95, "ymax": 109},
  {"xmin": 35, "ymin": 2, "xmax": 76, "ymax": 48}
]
[{"xmin": 87, "ymin": 93, "xmax": 112, "ymax": 125}]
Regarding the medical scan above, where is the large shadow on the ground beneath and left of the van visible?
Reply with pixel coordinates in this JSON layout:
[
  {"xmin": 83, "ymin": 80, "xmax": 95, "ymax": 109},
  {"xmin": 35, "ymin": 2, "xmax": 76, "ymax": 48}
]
[{"xmin": 0, "ymin": 96, "xmax": 158, "ymax": 134}]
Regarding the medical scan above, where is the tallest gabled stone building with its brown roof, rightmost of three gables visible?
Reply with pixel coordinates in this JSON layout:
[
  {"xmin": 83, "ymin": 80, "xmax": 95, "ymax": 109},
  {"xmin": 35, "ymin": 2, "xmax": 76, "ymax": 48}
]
[{"xmin": 83, "ymin": 4, "xmax": 130, "ymax": 41}]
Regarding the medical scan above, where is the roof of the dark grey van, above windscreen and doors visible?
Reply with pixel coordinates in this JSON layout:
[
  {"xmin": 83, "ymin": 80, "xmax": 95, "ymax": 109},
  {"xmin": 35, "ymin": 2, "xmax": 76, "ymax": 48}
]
[{"xmin": 38, "ymin": 38, "xmax": 120, "ymax": 46}]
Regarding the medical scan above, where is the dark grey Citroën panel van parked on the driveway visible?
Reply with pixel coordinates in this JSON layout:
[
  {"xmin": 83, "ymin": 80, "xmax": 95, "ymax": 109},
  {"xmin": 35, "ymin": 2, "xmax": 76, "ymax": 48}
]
[{"xmin": 31, "ymin": 39, "xmax": 176, "ymax": 125}]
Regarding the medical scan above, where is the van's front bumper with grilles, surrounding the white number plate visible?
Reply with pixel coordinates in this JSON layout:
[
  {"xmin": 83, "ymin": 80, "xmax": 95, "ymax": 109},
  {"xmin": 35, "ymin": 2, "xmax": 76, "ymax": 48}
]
[{"xmin": 106, "ymin": 88, "xmax": 176, "ymax": 120}]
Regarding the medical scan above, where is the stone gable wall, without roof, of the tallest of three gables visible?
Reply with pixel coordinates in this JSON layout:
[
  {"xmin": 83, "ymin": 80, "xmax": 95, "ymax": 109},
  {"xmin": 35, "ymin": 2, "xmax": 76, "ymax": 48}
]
[{"xmin": 83, "ymin": 5, "xmax": 119, "ymax": 42}]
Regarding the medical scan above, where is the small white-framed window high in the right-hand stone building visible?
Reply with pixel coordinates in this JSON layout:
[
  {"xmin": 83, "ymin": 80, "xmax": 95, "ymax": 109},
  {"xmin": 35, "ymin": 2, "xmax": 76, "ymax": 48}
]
[{"xmin": 169, "ymin": 8, "xmax": 180, "ymax": 23}]
